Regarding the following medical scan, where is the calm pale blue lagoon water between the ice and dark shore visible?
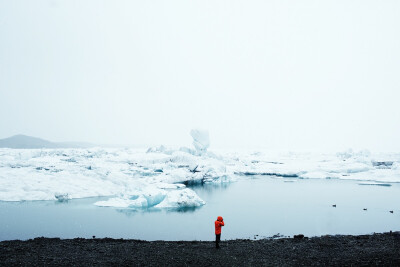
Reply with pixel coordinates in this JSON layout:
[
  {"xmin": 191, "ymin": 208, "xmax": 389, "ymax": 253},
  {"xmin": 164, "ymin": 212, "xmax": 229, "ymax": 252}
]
[{"xmin": 0, "ymin": 177, "xmax": 400, "ymax": 243}]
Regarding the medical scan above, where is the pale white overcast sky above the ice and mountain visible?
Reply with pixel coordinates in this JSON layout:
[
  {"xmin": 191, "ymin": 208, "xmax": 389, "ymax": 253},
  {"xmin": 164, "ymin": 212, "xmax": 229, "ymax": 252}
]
[{"xmin": 0, "ymin": 0, "xmax": 400, "ymax": 151}]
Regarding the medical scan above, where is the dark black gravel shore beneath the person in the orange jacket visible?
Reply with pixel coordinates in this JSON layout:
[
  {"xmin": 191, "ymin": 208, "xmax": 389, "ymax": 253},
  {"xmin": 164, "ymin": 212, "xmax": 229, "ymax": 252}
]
[{"xmin": 0, "ymin": 232, "xmax": 400, "ymax": 266}]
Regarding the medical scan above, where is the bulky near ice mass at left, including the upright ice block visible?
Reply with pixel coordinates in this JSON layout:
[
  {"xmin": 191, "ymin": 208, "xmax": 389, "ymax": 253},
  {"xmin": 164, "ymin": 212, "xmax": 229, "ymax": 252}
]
[{"xmin": 0, "ymin": 131, "xmax": 230, "ymax": 209}]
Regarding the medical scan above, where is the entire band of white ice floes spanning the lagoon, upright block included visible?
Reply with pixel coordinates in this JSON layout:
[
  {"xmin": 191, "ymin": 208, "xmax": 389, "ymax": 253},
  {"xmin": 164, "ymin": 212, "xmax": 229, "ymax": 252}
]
[{"xmin": 0, "ymin": 136, "xmax": 400, "ymax": 208}]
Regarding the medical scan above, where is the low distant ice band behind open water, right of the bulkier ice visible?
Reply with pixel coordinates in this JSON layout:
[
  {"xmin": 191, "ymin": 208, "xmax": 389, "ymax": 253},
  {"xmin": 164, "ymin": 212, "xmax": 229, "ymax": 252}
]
[{"xmin": 227, "ymin": 150, "xmax": 400, "ymax": 183}]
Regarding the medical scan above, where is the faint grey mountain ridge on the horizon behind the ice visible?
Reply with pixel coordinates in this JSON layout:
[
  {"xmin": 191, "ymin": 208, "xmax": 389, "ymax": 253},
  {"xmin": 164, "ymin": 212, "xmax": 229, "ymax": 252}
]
[{"xmin": 0, "ymin": 134, "xmax": 95, "ymax": 149}]
